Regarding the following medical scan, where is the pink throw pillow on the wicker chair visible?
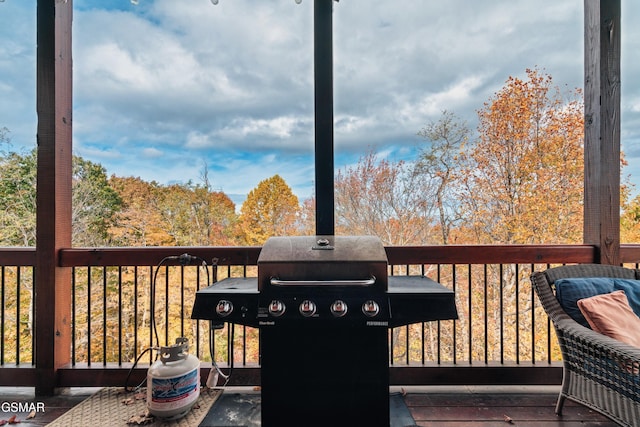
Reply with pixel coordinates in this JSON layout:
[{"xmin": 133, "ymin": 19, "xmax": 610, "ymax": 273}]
[{"xmin": 578, "ymin": 291, "xmax": 640, "ymax": 348}]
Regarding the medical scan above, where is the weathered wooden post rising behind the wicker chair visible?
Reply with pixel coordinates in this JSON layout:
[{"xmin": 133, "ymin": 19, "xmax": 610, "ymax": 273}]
[{"xmin": 584, "ymin": 0, "xmax": 621, "ymax": 265}]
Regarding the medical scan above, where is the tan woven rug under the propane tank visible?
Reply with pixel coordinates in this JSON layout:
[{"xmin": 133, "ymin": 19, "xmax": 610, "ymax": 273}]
[{"xmin": 48, "ymin": 387, "xmax": 221, "ymax": 427}]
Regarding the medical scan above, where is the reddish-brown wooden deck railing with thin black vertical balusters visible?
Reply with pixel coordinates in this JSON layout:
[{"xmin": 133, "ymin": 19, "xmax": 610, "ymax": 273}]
[{"xmin": 0, "ymin": 245, "xmax": 640, "ymax": 387}]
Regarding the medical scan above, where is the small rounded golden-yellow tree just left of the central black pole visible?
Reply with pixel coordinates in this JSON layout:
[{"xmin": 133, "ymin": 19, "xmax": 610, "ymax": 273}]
[{"xmin": 239, "ymin": 175, "xmax": 300, "ymax": 245}]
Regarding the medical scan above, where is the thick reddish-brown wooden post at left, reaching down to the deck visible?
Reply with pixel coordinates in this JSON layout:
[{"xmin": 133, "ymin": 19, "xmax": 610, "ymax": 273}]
[{"xmin": 34, "ymin": 0, "xmax": 73, "ymax": 395}]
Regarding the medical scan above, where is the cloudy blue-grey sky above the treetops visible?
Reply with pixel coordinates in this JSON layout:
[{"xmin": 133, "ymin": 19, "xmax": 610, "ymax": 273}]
[{"xmin": 0, "ymin": 0, "xmax": 640, "ymax": 207}]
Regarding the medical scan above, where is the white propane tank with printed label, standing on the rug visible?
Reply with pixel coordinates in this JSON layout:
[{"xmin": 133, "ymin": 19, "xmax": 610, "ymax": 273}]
[{"xmin": 147, "ymin": 338, "xmax": 200, "ymax": 420}]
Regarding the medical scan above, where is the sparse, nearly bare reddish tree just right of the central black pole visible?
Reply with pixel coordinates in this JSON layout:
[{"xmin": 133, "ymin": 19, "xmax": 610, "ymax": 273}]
[{"xmin": 335, "ymin": 152, "xmax": 431, "ymax": 245}]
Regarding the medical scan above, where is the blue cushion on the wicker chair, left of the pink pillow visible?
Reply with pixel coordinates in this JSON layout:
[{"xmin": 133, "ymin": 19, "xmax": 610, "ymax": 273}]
[{"xmin": 555, "ymin": 277, "xmax": 616, "ymax": 328}]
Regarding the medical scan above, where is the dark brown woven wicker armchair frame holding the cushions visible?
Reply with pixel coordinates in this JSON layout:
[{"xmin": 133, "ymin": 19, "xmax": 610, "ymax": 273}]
[{"xmin": 531, "ymin": 264, "xmax": 640, "ymax": 427}]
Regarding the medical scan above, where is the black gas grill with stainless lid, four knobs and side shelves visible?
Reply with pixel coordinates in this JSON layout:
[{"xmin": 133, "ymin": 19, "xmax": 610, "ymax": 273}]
[{"xmin": 192, "ymin": 236, "xmax": 457, "ymax": 427}]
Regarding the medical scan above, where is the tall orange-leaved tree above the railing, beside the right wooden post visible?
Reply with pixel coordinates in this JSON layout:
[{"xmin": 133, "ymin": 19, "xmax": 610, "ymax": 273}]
[{"xmin": 459, "ymin": 70, "xmax": 584, "ymax": 244}]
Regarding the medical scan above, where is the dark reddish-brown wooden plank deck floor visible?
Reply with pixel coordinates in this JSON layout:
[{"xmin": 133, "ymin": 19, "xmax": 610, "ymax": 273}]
[{"xmin": 0, "ymin": 387, "xmax": 616, "ymax": 427}]
